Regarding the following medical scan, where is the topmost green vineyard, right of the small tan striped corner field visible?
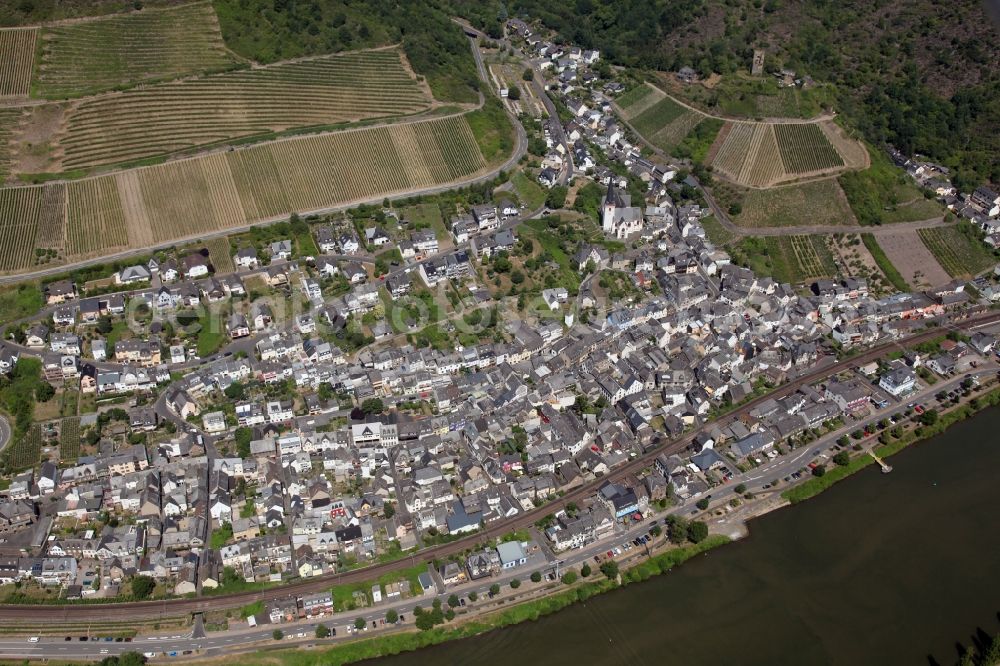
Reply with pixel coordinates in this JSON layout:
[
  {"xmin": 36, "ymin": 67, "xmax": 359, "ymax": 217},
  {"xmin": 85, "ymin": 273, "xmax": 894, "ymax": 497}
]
[{"xmin": 34, "ymin": 2, "xmax": 244, "ymax": 99}]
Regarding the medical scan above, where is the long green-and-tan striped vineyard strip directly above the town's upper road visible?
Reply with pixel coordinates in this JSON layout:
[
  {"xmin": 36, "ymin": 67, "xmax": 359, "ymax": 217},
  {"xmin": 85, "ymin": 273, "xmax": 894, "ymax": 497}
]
[{"xmin": 0, "ymin": 116, "xmax": 487, "ymax": 271}]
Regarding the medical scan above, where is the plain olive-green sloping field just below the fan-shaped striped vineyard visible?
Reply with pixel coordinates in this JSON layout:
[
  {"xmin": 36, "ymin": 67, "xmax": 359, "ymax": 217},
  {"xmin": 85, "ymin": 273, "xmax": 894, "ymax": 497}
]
[{"xmin": 713, "ymin": 179, "xmax": 856, "ymax": 228}]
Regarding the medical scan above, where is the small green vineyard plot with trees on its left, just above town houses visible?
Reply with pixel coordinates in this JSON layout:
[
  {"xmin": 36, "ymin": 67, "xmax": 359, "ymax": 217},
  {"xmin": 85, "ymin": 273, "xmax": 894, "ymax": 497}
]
[{"xmin": 733, "ymin": 235, "xmax": 838, "ymax": 285}]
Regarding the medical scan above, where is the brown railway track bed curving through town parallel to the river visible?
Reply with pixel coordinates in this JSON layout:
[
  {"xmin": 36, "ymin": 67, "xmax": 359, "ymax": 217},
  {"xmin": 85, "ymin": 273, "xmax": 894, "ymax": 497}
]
[{"xmin": 0, "ymin": 312, "xmax": 1000, "ymax": 621}]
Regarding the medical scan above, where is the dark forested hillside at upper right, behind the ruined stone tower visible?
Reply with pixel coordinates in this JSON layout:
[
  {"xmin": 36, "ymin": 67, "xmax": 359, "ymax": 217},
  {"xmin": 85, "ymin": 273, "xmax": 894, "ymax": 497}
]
[{"xmin": 453, "ymin": 0, "xmax": 1000, "ymax": 187}]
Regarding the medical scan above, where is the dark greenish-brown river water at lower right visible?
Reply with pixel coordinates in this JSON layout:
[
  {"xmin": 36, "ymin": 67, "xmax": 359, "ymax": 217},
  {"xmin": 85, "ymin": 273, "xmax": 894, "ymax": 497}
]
[{"xmin": 372, "ymin": 409, "xmax": 1000, "ymax": 666}]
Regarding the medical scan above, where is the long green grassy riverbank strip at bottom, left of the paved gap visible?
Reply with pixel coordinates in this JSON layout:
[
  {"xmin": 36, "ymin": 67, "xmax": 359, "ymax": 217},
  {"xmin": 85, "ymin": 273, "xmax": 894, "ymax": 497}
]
[{"xmin": 205, "ymin": 535, "xmax": 729, "ymax": 666}]
